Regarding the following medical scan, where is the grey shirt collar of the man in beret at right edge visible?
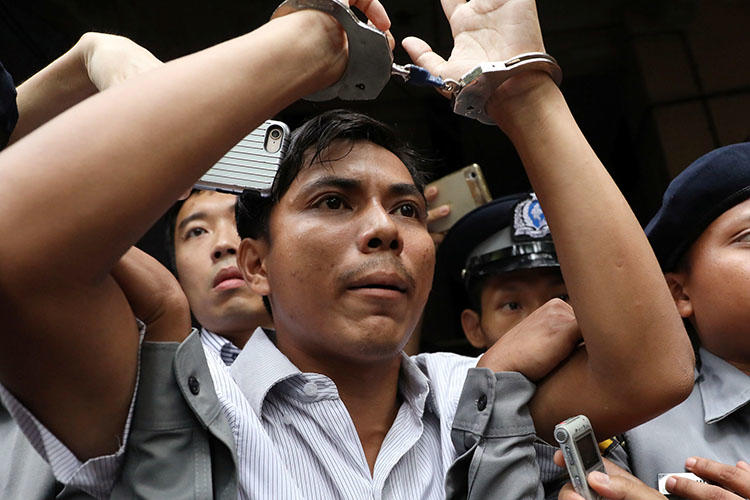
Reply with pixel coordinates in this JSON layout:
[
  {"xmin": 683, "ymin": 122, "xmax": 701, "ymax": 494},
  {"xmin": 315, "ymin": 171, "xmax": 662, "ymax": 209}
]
[{"xmin": 696, "ymin": 347, "xmax": 750, "ymax": 424}]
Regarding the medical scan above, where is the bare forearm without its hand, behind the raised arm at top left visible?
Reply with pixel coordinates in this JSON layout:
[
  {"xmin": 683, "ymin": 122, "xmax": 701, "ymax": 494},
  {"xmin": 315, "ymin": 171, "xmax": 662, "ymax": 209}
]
[{"xmin": 9, "ymin": 34, "xmax": 97, "ymax": 144}]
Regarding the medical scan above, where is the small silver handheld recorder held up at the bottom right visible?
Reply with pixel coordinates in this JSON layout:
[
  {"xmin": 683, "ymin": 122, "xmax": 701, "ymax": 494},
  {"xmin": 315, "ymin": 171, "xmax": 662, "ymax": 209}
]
[{"xmin": 554, "ymin": 415, "xmax": 606, "ymax": 500}]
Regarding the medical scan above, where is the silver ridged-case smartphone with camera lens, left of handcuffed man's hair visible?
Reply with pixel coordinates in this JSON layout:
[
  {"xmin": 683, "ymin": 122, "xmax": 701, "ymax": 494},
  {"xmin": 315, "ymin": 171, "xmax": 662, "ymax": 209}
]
[{"xmin": 195, "ymin": 120, "xmax": 289, "ymax": 194}]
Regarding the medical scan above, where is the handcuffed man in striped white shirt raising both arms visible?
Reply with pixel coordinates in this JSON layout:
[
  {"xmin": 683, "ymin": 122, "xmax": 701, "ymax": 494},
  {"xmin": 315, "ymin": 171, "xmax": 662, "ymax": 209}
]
[{"xmin": 0, "ymin": 0, "xmax": 692, "ymax": 497}]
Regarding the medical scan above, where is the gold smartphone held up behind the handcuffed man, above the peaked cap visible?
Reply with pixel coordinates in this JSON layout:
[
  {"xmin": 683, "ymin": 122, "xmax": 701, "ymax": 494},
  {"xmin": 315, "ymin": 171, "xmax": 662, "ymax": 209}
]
[{"xmin": 425, "ymin": 163, "xmax": 492, "ymax": 233}]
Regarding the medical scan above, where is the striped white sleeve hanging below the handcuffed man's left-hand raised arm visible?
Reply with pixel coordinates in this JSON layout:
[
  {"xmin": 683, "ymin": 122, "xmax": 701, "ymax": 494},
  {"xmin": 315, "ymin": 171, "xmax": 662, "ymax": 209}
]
[{"xmin": 0, "ymin": 320, "xmax": 146, "ymax": 498}]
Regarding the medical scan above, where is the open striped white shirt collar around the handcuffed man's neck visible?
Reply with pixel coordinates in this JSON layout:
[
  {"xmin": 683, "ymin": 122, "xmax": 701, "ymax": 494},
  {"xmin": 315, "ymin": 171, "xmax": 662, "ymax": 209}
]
[{"xmin": 230, "ymin": 328, "xmax": 437, "ymax": 419}]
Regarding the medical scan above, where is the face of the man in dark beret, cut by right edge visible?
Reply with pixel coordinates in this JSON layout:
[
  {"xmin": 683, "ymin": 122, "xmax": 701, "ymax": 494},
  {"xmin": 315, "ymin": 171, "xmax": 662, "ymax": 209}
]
[{"xmin": 676, "ymin": 200, "xmax": 750, "ymax": 364}]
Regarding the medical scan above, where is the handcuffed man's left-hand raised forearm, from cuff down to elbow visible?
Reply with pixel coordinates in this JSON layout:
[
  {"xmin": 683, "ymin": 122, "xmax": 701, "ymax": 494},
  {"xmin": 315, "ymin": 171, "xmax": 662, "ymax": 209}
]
[{"xmin": 0, "ymin": 11, "xmax": 346, "ymax": 290}]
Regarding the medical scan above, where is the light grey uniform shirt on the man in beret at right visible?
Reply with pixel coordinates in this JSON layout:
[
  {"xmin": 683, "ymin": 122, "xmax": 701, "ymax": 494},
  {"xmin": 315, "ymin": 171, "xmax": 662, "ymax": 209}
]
[{"xmin": 625, "ymin": 348, "xmax": 750, "ymax": 487}]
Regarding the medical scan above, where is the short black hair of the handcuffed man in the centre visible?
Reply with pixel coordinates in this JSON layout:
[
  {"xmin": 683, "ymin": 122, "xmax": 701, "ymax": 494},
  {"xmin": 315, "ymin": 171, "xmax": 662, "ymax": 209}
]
[{"xmin": 235, "ymin": 109, "xmax": 432, "ymax": 241}]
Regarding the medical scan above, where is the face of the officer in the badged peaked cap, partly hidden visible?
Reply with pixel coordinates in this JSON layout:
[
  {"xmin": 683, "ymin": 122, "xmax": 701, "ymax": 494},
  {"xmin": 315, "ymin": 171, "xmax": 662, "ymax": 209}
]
[{"xmin": 461, "ymin": 268, "xmax": 568, "ymax": 349}]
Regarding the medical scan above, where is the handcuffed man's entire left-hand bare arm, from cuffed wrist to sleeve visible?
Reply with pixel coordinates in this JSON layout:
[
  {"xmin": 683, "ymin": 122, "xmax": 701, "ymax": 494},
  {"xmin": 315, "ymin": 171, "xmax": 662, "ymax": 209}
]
[{"xmin": 0, "ymin": 0, "xmax": 388, "ymax": 460}]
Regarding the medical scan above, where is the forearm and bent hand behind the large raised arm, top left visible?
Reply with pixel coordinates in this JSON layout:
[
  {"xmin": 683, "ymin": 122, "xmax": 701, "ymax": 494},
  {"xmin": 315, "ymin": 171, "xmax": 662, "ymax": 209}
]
[{"xmin": 9, "ymin": 33, "xmax": 162, "ymax": 143}]
